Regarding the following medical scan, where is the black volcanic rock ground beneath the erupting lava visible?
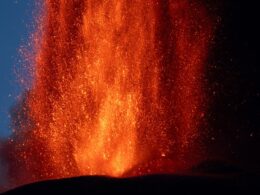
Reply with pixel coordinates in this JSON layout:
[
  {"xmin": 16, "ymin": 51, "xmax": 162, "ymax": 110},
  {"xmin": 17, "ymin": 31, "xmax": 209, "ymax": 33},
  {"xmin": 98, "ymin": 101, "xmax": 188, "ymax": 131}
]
[{"xmin": 3, "ymin": 174, "xmax": 260, "ymax": 195}]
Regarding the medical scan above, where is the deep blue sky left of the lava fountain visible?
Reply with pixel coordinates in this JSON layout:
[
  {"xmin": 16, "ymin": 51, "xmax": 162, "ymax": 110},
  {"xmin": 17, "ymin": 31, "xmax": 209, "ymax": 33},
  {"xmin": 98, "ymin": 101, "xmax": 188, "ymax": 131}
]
[{"xmin": 0, "ymin": 0, "xmax": 35, "ymax": 138}]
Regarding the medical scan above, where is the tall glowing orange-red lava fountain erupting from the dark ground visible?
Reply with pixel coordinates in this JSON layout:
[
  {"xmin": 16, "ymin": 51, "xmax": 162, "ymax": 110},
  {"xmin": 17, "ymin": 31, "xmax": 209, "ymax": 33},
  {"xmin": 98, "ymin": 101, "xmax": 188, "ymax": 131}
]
[{"xmin": 3, "ymin": 0, "xmax": 212, "ymax": 189}]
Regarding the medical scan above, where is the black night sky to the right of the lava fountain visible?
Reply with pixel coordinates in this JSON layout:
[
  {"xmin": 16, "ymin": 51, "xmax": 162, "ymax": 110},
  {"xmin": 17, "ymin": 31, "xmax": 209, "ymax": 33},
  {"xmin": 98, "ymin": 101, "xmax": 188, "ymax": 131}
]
[{"xmin": 207, "ymin": 0, "xmax": 260, "ymax": 170}]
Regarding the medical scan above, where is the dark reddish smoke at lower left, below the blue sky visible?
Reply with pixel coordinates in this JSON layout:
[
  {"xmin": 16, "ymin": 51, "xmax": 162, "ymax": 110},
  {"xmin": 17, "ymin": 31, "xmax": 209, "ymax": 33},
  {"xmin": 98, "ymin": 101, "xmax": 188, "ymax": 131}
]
[{"xmin": 0, "ymin": 91, "xmax": 33, "ymax": 189}]
